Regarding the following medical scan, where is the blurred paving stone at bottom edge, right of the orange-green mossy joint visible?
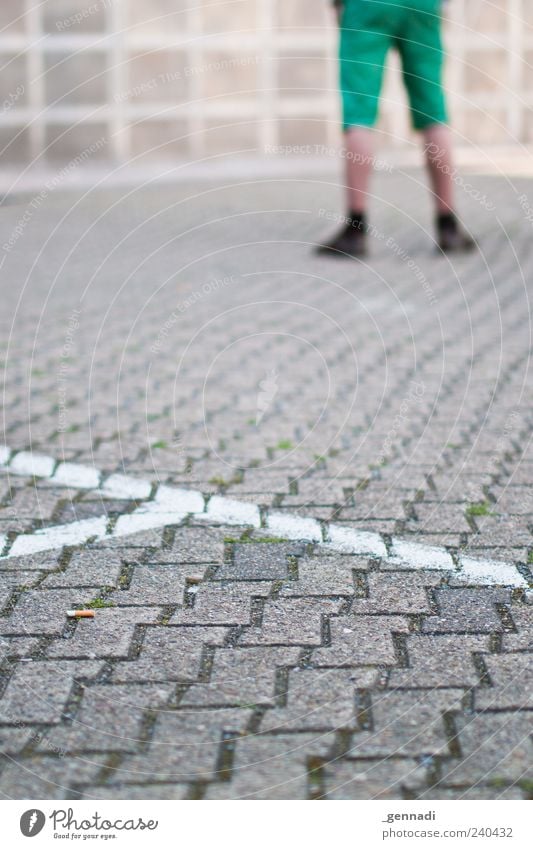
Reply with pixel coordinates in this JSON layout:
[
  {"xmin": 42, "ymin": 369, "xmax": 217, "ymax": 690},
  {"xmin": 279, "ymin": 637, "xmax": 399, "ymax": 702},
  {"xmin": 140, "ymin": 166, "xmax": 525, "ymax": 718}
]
[{"xmin": 324, "ymin": 758, "xmax": 426, "ymax": 799}]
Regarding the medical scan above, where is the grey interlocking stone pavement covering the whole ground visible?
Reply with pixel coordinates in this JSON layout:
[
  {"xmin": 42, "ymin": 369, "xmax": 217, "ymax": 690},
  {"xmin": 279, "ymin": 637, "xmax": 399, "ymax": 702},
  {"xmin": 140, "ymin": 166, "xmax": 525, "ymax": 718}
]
[{"xmin": 0, "ymin": 171, "xmax": 533, "ymax": 799}]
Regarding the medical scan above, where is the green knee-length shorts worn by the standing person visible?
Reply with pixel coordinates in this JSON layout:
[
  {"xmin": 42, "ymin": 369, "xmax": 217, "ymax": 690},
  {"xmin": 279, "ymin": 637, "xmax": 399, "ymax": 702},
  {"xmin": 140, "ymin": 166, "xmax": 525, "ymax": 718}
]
[{"xmin": 340, "ymin": 0, "xmax": 448, "ymax": 130}]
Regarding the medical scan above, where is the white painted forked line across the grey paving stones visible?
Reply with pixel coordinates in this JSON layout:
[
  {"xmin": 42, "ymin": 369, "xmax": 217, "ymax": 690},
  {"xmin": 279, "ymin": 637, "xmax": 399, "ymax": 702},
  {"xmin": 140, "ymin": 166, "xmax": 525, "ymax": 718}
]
[{"xmin": 0, "ymin": 446, "xmax": 529, "ymax": 589}]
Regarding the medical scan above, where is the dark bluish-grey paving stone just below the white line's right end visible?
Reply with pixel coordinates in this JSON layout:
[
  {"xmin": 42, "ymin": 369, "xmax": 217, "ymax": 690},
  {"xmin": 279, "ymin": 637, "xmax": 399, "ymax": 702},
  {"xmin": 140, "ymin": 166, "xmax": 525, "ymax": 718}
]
[{"xmin": 422, "ymin": 588, "xmax": 511, "ymax": 633}]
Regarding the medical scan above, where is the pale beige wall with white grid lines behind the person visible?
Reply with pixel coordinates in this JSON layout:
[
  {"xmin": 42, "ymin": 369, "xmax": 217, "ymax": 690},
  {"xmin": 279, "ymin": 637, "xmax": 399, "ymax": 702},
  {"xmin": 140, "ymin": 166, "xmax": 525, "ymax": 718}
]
[{"xmin": 0, "ymin": 0, "xmax": 533, "ymax": 164}]
